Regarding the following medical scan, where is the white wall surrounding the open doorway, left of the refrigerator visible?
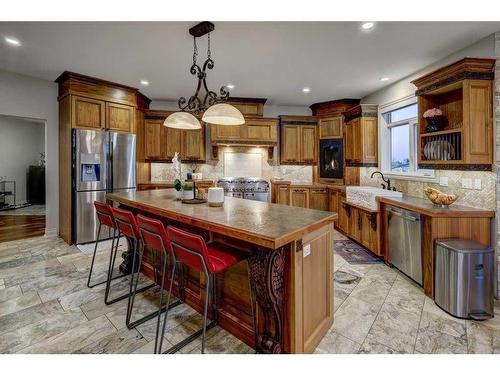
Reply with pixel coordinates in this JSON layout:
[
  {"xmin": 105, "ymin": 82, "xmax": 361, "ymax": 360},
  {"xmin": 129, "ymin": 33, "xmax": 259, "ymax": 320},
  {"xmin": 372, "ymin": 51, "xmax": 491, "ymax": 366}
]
[{"xmin": 0, "ymin": 70, "xmax": 59, "ymax": 235}]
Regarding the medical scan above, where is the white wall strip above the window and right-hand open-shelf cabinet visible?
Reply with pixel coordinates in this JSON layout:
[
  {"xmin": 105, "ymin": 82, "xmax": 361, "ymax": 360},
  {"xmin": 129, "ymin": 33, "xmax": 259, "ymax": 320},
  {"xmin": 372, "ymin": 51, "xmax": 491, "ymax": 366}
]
[{"xmin": 361, "ymin": 34, "xmax": 495, "ymax": 105}]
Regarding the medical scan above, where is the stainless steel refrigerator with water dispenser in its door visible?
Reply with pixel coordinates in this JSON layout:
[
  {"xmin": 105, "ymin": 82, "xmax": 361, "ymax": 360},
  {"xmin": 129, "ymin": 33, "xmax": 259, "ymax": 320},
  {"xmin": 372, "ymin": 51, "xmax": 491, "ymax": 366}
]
[{"xmin": 72, "ymin": 129, "xmax": 136, "ymax": 244}]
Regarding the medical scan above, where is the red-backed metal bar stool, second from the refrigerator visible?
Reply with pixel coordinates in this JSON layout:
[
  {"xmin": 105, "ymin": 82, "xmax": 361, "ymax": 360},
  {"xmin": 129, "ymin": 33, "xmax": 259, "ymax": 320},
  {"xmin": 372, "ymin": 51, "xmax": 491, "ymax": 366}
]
[{"xmin": 108, "ymin": 207, "xmax": 156, "ymax": 314}]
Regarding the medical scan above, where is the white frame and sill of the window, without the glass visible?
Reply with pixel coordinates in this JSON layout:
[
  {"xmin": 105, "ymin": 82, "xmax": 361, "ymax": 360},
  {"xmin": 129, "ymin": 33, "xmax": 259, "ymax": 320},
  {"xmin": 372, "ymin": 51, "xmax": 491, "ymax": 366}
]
[{"xmin": 378, "ymin": 95, "xmax": 436, "ymax": 182}]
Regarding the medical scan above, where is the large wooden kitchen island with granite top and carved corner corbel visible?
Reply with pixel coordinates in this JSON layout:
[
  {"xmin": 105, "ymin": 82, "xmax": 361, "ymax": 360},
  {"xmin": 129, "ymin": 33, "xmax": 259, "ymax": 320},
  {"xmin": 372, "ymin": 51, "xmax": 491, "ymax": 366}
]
[{"xmin": 106, "ymin": 189, "xmax": 337, "ymax": 353}]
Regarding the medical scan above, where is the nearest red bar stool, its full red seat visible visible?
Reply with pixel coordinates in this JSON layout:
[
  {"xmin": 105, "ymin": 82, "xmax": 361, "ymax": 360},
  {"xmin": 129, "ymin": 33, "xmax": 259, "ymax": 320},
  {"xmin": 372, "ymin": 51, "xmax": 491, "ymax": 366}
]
[{"xmin": 157, "ymin": 225, "xmax": 256, "ymax": 354}]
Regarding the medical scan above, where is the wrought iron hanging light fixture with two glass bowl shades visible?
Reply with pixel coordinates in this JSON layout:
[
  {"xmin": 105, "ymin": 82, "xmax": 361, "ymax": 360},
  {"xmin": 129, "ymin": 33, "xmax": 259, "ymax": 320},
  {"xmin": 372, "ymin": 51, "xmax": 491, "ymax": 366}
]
[{"xmin": 163, "ymin": 21, "xmax": 245, "ymax": 129}]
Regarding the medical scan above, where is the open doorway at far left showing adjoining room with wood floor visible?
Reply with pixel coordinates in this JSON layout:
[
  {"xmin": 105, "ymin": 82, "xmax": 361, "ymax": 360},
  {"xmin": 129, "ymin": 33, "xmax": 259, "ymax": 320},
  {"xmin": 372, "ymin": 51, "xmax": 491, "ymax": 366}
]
[{"xmin": 0, "ymin": 115, "xmax": 46, "ymax": 242}]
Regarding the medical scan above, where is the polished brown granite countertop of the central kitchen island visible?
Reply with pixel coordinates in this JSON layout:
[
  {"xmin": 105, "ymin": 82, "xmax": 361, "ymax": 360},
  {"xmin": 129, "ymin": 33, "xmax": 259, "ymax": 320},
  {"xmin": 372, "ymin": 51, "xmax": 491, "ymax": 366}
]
[{"xmin": 106, "ymin": 189, "xmax": 337, "ymax": 249}]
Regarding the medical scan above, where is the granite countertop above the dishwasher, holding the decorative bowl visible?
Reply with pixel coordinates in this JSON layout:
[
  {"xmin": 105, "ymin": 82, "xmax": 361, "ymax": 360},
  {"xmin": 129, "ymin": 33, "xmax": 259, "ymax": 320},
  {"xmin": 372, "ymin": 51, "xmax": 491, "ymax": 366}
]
[{"xmin": 377, "ymin": 194, "xmax": 495, "ymax": 217}]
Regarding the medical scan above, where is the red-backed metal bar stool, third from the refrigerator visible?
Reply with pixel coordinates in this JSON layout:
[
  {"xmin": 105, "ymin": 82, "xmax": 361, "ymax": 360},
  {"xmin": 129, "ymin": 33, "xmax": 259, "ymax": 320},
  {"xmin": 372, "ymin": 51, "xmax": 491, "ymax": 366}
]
[{"xmin": 135, "ymin": 214, "xmax": 184, "ymax": 353}]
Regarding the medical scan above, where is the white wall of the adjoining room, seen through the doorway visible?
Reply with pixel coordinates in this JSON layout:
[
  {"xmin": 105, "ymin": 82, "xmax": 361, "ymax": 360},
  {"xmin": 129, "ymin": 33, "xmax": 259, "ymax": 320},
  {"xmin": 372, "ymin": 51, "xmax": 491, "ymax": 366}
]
[{"xmin": 0, "ymin": 116, "xmax": 45, "ymax": 204}]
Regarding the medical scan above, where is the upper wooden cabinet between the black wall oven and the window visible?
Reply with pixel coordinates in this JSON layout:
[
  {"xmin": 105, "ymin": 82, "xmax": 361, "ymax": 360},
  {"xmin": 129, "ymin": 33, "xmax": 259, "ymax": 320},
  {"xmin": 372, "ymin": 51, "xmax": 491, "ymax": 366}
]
[{"xmin": 344, "ymin": 104, "xmax": 378, "ymax": 167}]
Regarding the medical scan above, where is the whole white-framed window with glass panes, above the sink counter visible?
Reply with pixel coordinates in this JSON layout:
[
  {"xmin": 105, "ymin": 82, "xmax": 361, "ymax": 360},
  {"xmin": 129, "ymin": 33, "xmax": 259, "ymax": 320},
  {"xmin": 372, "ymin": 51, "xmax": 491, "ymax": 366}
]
[{"xmin": 380, "ymin": 97, "xmax": 434, "ymax": 178}]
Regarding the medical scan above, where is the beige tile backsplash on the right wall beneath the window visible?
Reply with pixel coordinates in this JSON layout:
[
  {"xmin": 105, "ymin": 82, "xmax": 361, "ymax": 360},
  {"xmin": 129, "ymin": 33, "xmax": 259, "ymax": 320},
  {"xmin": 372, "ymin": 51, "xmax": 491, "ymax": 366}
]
[{"xmin": 360, "ymin": 168, "xmax": 496, "ymax": 210}]
